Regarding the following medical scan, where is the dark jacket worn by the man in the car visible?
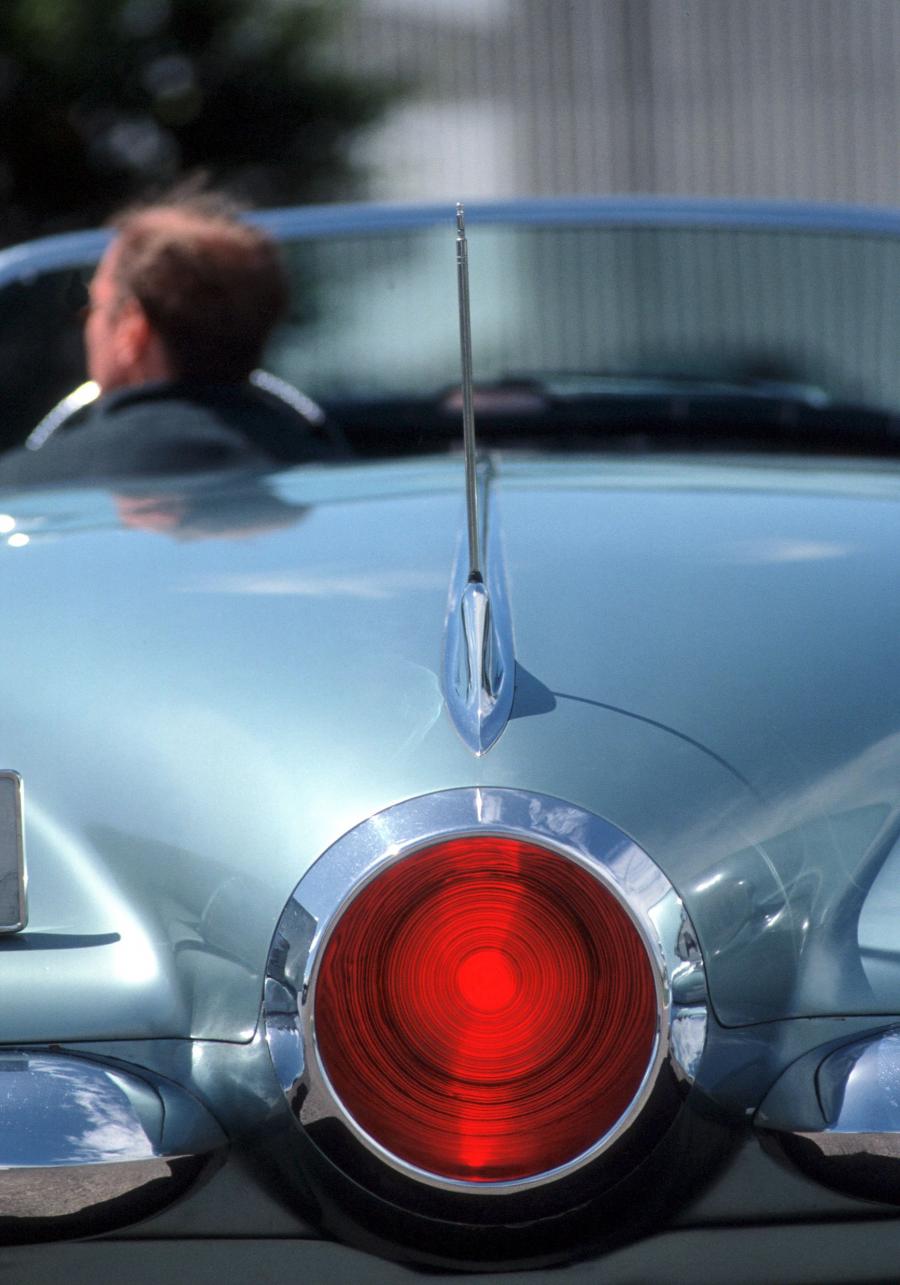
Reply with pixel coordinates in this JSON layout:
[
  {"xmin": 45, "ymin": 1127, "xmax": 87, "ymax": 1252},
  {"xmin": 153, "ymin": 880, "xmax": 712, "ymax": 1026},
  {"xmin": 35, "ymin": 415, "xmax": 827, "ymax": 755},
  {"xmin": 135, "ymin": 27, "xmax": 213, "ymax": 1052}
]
[{"xmin": 0, "ymin": 383, "xmax": 329, "ymax": 488}]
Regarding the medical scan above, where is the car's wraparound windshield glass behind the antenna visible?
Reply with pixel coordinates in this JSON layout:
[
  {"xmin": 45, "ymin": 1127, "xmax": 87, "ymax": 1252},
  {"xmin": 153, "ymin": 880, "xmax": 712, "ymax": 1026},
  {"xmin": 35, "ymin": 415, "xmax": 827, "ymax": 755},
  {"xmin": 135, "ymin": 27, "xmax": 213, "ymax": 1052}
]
[{"xmin": 0, "ymin": 203, "xmax": 900, "ymax": 454}]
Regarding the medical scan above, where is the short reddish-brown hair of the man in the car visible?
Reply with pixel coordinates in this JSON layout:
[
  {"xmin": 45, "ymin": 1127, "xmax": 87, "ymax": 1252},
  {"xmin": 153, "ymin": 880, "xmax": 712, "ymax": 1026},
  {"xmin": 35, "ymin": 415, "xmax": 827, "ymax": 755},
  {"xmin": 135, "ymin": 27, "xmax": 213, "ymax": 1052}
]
[{"xmin": 113, "ymin": 195, "xmax": 288, "ymax": 383}]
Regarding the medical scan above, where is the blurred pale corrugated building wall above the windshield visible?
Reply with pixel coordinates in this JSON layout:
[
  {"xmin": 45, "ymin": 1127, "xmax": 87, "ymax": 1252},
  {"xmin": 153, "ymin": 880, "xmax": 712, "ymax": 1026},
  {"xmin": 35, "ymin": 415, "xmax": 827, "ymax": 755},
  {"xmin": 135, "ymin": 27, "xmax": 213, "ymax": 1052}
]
[{"xmin": 336, "ymin": 0, "xmax": 900, "ymax": 206}]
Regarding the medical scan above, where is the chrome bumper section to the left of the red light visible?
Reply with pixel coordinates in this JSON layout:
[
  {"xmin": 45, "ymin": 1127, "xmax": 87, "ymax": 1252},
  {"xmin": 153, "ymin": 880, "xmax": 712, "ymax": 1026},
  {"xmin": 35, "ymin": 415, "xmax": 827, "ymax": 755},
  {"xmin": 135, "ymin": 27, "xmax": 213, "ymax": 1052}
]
[{"xmin": 0, "ymin": 1050, "xmax": 225, "ymax": 1231}]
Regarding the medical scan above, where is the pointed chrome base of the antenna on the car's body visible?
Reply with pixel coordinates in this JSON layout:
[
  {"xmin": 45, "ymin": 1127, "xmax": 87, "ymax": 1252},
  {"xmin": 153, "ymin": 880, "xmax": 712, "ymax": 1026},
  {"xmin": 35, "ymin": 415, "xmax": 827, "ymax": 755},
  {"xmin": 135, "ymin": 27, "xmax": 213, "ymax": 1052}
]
[{"xmin": 441, "ymin": 464, "xmax": 516, "ymax": 757}]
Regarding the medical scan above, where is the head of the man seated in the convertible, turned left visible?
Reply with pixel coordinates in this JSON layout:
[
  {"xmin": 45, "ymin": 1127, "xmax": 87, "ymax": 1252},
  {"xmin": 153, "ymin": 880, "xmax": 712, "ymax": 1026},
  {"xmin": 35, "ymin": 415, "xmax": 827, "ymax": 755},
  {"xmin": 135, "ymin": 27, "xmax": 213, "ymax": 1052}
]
[{"xmin": 85, "ymin": 198, "xmax": 287, "ymax": 392}]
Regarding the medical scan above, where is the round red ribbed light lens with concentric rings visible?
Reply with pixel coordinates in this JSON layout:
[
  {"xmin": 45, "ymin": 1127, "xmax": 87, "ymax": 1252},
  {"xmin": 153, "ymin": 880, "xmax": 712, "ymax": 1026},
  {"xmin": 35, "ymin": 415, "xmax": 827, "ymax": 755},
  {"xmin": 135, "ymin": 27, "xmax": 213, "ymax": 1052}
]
[{"xmin": 315, "ymin": 837, "xmax": 658, "ymax": 1182}]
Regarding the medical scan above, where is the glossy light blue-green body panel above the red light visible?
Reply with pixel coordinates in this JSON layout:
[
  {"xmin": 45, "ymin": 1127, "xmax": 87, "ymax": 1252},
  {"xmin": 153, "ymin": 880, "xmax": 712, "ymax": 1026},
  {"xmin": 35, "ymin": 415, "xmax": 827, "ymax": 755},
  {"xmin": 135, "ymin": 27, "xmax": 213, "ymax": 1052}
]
[{"xmin": 0, "ymin": 457, "xmax": 900, "ymax": 1041}]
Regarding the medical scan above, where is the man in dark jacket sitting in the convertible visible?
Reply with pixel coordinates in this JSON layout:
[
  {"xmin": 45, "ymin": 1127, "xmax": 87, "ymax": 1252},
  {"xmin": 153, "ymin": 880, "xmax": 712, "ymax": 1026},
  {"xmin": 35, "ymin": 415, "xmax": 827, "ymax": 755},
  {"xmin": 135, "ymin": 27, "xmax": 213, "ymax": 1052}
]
[{"xmin": 0, "ymin": 197, "xmax": 324, "ymax": 487}]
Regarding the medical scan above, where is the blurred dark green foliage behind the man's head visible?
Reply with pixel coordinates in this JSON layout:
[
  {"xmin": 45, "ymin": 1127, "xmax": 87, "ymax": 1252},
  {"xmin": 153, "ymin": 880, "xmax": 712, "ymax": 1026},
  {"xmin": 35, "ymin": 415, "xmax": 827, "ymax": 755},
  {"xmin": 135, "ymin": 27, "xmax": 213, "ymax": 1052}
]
[{"xmin": 0, "ymin": 0, "xmax": 391, "ymax": 244}]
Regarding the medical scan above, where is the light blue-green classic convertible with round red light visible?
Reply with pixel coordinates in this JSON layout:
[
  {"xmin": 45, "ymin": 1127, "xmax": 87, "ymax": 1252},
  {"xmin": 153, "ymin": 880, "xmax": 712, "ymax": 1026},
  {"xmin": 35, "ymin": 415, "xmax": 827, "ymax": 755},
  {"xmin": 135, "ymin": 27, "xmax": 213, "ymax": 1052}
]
[{"xmin": 0, "ymin": 192, "xmax": 900, "ymax": 1282}]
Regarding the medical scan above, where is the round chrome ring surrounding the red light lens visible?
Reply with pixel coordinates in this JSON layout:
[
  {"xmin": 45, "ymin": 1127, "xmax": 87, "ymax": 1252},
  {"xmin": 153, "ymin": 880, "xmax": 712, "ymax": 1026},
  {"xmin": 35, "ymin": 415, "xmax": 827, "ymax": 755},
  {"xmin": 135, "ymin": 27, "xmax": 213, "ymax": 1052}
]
[{"xmin": 264, "ymin": 788, "xmax": 706, "ymax": 1199}]
